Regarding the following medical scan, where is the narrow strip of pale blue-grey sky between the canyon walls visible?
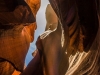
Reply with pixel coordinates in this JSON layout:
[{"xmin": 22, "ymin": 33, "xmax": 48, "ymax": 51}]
[{"xmin": 25, "ymin": 0, "xmax": 49, "ymax": 65}]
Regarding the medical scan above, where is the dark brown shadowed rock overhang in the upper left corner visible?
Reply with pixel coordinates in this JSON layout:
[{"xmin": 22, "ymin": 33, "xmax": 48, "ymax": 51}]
[{"xmin": 0, "ymin": 0, "xmax": 35, "ymax": 25}]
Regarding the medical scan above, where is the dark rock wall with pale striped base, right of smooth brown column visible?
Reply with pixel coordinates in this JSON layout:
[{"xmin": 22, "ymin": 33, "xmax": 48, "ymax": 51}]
[{"xmin": 49, "ymin": 0, "xmax": 100, "ymax": 75}]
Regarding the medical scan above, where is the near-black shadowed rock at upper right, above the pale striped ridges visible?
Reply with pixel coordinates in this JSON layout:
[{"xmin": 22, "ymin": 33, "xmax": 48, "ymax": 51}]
[{"xmin": 50, "ymin": 0, "xmax": 99, "ymax": 51}]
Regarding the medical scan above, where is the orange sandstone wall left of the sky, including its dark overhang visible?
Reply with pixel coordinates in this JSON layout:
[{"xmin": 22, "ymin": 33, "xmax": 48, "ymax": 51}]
[{"xmin": 0, "ymin": 0, "xmax": 40, "ymax": 75}]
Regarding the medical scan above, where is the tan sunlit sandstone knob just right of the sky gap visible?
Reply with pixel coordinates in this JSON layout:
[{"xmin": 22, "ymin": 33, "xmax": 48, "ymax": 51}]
[{"xmin": 45, "ymin": 4, "xmax": 58, "ymax": 30}]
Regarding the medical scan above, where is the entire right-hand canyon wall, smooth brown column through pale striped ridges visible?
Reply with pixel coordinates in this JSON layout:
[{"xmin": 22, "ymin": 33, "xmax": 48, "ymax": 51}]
[{"xmin": 22, "ymin": 0, "xmax": 100, "ymax": 75}]
